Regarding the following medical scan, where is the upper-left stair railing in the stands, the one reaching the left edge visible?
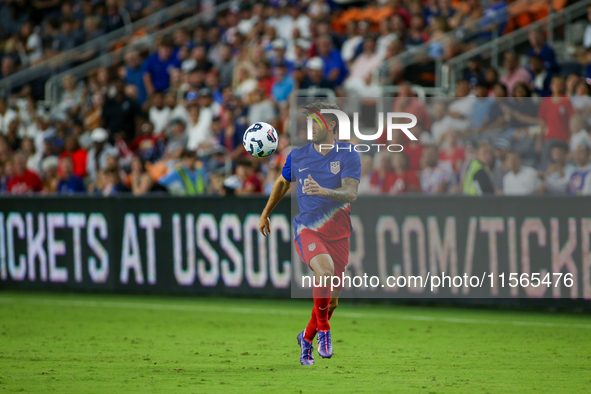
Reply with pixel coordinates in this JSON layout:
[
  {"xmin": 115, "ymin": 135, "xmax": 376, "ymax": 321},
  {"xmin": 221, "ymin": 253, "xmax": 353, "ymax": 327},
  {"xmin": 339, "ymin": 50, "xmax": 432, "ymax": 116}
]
[{"xmin": 0, "ymin": 0, "xmax": 211, "ymax": 97}]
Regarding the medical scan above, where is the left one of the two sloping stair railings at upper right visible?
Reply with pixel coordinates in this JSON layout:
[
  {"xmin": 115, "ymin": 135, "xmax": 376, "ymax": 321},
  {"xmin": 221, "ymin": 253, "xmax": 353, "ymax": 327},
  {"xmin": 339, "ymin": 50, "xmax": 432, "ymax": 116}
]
[{"xmin": 373, "ymin": 0, "xmax": 552, "ymax": 86}]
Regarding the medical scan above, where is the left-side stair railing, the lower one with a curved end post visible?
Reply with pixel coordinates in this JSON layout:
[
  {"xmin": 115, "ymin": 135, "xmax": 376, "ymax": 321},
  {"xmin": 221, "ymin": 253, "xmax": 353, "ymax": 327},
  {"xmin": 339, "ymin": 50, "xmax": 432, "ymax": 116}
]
[{"xmin": 45, "ymin": 0, "xmax": 233, "ymax": 106}]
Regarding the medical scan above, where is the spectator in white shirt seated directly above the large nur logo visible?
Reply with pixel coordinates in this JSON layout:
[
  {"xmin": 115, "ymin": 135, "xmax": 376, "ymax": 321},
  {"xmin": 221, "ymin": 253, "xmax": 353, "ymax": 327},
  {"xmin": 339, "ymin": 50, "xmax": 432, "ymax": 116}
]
[{"xmin": 343, "ymin": 36, "xmax": 384, "ymax": 97}]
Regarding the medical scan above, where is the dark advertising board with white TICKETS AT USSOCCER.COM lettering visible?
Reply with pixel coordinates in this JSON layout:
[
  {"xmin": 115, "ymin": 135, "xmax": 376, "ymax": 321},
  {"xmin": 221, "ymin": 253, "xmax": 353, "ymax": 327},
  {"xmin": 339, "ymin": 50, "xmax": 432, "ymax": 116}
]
[{"xmin": 0, "ymin": 196, "xmax": 591, "ymax": 309}]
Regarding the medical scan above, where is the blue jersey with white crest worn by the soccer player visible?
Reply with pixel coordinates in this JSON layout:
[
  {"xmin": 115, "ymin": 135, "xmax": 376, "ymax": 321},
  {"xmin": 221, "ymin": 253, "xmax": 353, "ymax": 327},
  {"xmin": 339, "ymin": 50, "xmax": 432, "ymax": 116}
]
[{"xmin": 282, "ymin": 141, "xmax": 361, "ymax": 240}]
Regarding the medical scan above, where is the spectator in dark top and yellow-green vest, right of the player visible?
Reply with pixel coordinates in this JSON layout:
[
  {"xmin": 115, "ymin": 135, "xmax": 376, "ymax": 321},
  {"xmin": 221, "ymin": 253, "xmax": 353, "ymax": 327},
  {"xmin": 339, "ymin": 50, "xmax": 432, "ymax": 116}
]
[{"xmin": 463, "ymin": 141, "xmax": 495, "ymax": 196}]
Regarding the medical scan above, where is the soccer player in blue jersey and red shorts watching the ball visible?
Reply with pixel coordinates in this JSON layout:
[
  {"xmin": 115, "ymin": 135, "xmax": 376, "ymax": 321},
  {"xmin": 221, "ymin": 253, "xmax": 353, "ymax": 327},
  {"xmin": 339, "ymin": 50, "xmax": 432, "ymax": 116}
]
[{"xmin": 259, "ymin": 101, "xmax": 361, "ymax": 365}]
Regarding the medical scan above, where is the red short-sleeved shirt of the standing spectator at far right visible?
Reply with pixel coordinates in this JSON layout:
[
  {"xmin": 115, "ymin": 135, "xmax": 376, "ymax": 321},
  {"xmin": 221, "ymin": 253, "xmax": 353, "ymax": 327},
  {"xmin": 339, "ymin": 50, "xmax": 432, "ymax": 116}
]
[{"xmin": 538, "ymin": 97, "xmax": 574, "ymax": 142}]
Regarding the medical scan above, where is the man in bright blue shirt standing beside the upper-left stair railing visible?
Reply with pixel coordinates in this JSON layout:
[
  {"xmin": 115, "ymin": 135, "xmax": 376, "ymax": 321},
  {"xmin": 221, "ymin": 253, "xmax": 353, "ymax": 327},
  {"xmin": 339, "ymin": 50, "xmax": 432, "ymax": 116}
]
[{"xmin": 142, "ymin": 37, "xmax": 181, "ymax": 95}]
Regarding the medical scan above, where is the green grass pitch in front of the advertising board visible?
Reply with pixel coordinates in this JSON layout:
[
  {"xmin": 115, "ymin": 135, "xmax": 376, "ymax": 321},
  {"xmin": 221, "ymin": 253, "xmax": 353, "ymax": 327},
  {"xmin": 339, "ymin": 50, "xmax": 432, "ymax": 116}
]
[{"xmin": 0, "ymin": 292, "xmax": 591, "ymax": 393}]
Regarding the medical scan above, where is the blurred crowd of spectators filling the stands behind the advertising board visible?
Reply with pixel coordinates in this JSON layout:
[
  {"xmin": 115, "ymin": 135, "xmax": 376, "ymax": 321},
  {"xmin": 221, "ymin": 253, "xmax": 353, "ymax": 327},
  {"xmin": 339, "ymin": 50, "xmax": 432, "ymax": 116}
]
[{"xmin": 0, "ymin": 0, "xmax": 591, "ymax": 196}]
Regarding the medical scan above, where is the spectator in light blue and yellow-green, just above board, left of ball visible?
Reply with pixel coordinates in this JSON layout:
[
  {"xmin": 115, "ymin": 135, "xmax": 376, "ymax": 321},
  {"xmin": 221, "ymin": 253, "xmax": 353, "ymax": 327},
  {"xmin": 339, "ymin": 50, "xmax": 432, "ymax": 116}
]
[{"xmin": 158, "ymin": 149, "xmax": 209, "ymax": 196}]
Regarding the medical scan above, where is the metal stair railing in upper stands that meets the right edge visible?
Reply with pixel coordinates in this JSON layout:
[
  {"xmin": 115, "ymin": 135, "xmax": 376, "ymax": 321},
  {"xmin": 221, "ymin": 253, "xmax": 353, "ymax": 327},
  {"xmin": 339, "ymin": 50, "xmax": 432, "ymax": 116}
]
[{"xmin": 439, "ymin": 0, "xmax": 591, "ymax": 94}]
